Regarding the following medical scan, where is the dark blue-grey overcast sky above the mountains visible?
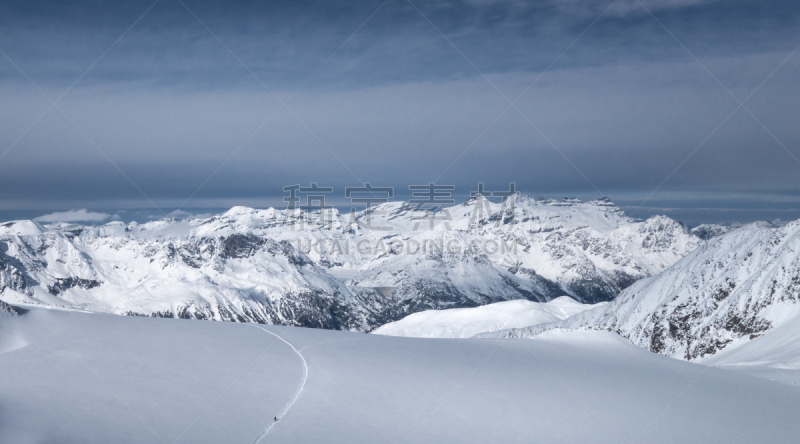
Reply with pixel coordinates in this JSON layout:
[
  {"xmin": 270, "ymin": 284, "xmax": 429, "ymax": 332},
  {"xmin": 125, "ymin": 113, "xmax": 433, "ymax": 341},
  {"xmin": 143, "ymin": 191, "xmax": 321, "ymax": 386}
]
[{"xmin": 0, "ymin": 0, "xmax": 800, "ymax": 224}]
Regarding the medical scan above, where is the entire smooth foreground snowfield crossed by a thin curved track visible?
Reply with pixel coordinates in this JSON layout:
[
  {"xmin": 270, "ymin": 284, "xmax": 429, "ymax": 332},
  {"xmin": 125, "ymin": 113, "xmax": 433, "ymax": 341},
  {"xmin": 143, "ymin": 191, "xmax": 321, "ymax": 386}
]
[{"xmin": 0, "ymin": 308, "xmax": 800, "ymax": 444}]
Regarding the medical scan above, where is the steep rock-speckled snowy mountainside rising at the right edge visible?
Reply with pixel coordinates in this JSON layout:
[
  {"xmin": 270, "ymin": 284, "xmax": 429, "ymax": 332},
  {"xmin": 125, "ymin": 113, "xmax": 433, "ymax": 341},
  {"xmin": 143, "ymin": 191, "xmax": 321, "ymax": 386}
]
[{"xmin": 484, "ymin": 221, "xmax": 800, "ymax": 362}]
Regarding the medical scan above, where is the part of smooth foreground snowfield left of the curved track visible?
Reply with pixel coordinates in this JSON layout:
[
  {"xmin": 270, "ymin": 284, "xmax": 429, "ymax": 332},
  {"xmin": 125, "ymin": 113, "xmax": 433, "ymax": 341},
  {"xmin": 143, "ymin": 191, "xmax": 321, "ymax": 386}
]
[{"xmin": 0, "ymin": 308, "xmax": 302, "ymax": 444}]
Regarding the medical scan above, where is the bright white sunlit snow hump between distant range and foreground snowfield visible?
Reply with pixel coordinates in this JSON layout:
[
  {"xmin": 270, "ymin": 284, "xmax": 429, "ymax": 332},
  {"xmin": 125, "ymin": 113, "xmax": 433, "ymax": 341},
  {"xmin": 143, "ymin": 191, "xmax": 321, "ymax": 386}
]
[{"xmin": 372, "ymin": 296, "xmax": 606, "ymax": 338}]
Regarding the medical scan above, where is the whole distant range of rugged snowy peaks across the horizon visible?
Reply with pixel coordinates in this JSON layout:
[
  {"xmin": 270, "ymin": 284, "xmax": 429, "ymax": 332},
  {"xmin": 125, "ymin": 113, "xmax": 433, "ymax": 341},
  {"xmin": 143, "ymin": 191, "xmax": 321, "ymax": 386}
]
[{"xmin": 0, "ymin": 195, "xmax": 702, "ymax": 331}]
